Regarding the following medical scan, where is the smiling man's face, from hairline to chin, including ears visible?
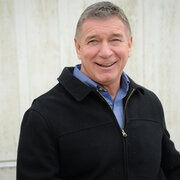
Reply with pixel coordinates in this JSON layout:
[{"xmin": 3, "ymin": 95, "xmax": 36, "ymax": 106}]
[{"xmin": 75, "ymin": 17, "xmax": 132, "ymax": 87}]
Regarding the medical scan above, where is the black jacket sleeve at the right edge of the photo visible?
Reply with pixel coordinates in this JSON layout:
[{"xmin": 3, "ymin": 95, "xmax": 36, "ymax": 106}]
[{"xmin": 162, "ymin": 116, "xmax": 180, "ymax": 180}]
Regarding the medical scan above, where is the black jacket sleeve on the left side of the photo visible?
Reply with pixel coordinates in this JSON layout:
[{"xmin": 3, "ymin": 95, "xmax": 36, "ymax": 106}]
[{"xmin": 17, "ymin": 110, "xmax": 63, "ymax": 180}]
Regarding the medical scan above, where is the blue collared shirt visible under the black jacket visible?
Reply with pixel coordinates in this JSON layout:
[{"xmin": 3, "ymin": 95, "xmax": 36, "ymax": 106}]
[{"xmin": 73, "ymin": 64, "xmax": 130, "ymax": 128}]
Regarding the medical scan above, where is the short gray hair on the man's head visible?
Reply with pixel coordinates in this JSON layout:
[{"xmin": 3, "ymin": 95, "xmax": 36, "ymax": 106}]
[{"xmin": 75, "ymin": 1, "xmax": 131, "ymax": 38}]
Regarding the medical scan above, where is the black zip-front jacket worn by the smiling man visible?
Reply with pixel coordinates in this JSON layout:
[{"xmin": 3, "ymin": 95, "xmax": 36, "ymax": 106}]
[{"xmin": 17, "ymin": 68, "xmax": 180, "ymax": 180}]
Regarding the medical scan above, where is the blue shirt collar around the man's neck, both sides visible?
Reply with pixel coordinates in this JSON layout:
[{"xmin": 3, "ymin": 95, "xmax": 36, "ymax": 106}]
[{"xmin": 73, "ymin": 64, "xmax": 130, "ymax": 92}]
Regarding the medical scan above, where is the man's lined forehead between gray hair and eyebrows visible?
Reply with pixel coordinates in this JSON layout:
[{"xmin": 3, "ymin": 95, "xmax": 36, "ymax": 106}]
[{"xmin": 81, "ymin": 17, "xmax": 127, "ymax": 38}]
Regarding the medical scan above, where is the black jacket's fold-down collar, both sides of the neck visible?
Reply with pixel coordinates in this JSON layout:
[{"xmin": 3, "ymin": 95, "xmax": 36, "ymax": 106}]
[{"xmin": 58, "ymin": 67, "xmax": 144, "ymax": 101}]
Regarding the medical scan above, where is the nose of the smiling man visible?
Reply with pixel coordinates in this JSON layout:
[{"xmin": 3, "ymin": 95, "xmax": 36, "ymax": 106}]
[{"xmin": 99, "ymin": 42, "xmax": 112, "ymax": 59}]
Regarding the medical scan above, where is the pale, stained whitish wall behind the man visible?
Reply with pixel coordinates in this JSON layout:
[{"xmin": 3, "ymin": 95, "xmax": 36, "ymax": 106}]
[{"xmin": 0, "ymin": 0, "xmax": 180, "ymax": 180}]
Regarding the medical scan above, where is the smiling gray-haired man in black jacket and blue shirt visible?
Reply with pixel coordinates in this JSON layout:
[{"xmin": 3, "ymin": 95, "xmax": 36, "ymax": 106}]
[{"xmin": 17, "ymin": 2, "xmax": 180, "ymax": 180}]
